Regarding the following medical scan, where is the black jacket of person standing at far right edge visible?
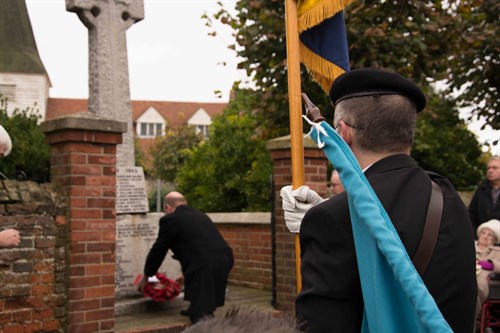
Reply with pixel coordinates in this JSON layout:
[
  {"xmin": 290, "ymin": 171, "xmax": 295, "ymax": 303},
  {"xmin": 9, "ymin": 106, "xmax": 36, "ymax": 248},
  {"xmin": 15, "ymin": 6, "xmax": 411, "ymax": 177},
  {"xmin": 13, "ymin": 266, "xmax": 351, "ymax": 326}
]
[{"xmin": 469, "ymin": 180, "xmax": 500, "ymax": 231}]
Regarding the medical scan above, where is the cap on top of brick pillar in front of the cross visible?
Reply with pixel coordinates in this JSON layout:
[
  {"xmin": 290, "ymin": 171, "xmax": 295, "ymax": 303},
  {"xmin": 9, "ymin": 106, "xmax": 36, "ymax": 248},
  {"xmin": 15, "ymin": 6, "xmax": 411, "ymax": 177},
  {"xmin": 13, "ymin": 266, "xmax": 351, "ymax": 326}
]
[{"xmin": 40, "ymin": 112, "xmax": 127, "ymax": 133}]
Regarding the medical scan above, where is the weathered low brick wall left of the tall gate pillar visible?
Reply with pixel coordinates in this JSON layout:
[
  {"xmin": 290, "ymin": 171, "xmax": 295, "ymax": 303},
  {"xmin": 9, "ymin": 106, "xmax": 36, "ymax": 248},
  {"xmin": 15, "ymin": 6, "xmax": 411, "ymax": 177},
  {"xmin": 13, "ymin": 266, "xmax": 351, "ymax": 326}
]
[{"xmin": 0, "ymin": 181, "xmax": 67, "ymax": 333}]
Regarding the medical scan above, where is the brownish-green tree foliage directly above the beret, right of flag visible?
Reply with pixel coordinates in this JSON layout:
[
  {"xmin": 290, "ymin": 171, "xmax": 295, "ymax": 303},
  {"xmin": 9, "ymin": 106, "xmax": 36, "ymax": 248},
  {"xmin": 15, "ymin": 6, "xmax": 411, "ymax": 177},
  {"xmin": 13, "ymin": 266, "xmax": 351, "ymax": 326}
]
[{"xmin": 346, "ymin": 0, "xmax": 455, "ymax": 85}]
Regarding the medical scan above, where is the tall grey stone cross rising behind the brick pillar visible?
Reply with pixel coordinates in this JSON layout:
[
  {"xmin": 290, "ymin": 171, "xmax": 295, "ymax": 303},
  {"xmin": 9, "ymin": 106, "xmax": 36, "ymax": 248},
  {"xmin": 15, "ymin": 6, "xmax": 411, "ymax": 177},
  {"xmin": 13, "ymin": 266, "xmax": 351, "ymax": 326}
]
[{"xmin": 66, "ymin": 0, "xmax": 144, "ymax": 166}]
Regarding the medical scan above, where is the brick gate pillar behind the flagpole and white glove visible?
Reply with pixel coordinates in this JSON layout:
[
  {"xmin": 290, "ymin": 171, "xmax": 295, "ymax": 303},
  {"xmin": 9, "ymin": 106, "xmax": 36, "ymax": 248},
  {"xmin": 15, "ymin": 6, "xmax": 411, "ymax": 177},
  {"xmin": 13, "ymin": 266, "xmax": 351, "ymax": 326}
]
[{"xmin": 267, "ymin": 136, "xmax": 327, "ymax": 311}]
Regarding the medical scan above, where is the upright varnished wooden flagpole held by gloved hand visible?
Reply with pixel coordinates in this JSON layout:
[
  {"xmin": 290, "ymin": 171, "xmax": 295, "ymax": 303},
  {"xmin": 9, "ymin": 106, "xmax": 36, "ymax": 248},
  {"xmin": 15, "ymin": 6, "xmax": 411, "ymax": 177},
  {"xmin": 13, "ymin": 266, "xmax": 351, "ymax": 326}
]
[{"xmin": 285, "ymin": 0, "xmax": 304, "ymax": 292}]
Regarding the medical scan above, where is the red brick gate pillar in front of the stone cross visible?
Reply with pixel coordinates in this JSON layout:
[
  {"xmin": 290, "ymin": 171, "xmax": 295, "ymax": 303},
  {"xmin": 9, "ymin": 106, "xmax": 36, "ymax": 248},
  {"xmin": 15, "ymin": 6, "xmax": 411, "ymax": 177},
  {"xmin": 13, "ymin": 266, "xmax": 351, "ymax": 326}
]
[{"xmin": 41, "ymin": 115, "xmax": 127, "ymax": 333}]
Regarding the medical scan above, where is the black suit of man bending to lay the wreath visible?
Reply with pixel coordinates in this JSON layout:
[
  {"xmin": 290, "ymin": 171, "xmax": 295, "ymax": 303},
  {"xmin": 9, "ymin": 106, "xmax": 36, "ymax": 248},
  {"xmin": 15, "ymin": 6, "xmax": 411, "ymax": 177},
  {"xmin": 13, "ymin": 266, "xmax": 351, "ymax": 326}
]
[{"xmin": 144, "ymin": 205, "xmax": 233, "ymax": 318}]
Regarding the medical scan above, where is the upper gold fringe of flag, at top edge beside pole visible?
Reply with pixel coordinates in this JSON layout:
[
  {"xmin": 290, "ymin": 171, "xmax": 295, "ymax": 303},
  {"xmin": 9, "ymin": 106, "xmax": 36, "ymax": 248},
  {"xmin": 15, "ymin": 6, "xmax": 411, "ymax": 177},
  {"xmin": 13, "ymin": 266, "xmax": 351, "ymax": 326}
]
[{"xmin": 297, "ymin": 0, "xmax": 354, "ymax": 33}]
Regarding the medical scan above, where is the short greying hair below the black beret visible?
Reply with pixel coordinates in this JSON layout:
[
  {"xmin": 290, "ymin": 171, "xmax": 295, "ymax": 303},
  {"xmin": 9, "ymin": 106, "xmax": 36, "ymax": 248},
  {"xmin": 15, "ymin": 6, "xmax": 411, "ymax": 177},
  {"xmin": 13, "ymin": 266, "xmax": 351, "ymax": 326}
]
[{"xmin": 334, "ymin": 94, "xmax": 417, "ymax": 153}]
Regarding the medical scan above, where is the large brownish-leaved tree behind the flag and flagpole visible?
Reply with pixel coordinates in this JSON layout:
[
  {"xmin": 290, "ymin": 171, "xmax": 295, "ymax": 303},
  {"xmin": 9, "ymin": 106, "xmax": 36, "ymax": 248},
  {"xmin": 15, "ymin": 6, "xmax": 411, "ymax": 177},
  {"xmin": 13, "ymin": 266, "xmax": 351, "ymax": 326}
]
[{"xmin": 207, "ymin": 0, "xmax": 488, "ymax": 184}]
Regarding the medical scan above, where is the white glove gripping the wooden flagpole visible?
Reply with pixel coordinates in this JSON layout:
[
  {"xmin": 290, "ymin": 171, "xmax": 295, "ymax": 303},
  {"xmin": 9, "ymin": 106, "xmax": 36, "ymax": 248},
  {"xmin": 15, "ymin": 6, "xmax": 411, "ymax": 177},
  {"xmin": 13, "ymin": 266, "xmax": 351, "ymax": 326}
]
[{"xmin": 280, "ymin": 185, "xmax": 325, "ymax": 233}]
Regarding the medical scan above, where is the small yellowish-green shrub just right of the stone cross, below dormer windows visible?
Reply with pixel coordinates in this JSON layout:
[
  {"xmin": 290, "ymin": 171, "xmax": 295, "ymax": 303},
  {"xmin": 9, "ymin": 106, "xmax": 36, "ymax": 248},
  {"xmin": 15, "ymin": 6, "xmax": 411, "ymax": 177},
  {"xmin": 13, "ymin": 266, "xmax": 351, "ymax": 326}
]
[{"xmin": 151, "ymin": 125, "xmax": 203, "ymax": 182}]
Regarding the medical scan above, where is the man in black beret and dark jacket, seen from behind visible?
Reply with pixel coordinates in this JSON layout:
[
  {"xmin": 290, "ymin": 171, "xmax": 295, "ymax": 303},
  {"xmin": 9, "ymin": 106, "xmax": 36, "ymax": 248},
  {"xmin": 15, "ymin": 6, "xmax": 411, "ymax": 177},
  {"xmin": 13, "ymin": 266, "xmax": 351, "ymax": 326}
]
[{"xmin": 295, "ymin": 69, "xmax": 477, "ymax": 333}]
